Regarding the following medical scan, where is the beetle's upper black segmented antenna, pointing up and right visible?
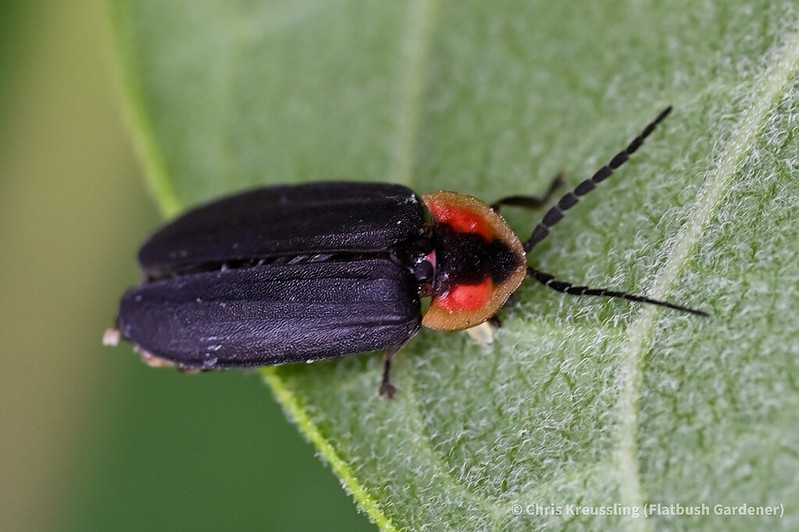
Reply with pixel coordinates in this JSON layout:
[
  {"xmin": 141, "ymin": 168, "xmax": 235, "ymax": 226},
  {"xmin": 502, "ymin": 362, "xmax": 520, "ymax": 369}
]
[{"xmin": 522, "ymin": 106, "xmax": 671, "ymax": 253}]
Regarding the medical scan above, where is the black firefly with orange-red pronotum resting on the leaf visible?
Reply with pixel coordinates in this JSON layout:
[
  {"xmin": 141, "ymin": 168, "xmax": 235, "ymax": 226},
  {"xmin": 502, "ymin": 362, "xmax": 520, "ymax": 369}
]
[{"xmin": 106, "ymin": 107, "xmax": 707, "ymax": 397}]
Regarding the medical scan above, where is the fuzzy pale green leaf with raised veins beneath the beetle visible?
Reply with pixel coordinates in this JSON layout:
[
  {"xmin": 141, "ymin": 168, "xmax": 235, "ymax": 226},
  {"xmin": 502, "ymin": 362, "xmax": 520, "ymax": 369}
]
[{"xmin": 112, "ymin": 0, "xmax": 799, "ymax": 530}]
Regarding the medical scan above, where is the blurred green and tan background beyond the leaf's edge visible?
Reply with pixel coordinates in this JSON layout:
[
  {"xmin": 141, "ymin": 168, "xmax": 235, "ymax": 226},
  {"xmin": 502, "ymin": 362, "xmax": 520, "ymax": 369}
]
[{"xmin": 0, "ymin": 1, "xmax": 373, "ymax": 531}]
